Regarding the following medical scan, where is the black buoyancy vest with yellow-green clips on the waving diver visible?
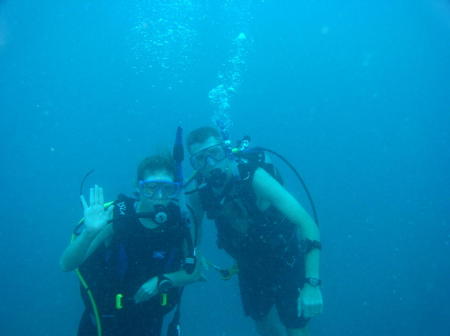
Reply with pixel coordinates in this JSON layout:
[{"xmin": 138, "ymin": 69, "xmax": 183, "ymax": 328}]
[{"xmin": 74, "ymin": 195, "xmax": 192, "ymax": 335}]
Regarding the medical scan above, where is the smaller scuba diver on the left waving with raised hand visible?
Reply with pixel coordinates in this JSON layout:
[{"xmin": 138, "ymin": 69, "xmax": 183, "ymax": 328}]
[{"xmin": 61, "ymin": 155, "xmax": 202, "ymax": 336}]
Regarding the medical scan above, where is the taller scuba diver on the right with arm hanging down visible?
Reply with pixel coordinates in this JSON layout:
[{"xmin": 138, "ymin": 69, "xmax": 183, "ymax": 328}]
[{"xmin": 187, "ymin": 127, "xmax": 323, "ymax": 336}]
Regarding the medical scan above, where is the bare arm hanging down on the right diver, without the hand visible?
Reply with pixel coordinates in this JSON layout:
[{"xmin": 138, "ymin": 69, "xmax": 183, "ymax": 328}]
[{"xmin": 253, "ymin": 168, "xmax": 320, "ymax": 278}]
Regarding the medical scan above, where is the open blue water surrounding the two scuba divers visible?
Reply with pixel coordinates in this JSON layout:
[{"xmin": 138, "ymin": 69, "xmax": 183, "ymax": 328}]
[{"xmin": 0, "ymin": 0, "xmax": 450, "ymax": 336}]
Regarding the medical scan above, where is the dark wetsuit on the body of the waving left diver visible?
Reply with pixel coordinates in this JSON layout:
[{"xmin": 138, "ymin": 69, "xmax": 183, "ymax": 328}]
[{"xmin": 75, "ymin": 196, "xmax": 185, "ymax": 336}]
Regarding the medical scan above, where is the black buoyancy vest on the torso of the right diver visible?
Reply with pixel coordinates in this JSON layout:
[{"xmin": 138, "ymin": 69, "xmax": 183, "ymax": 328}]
[{"xmin": 199, "ymin": 153, "xmax": 297, "ymax": 263}]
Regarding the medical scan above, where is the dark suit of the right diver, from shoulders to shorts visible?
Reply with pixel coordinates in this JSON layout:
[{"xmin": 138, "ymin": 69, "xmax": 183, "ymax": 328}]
[{"xmin": 199, "ymin": 164, "xmax": 307, "ymax": 328}]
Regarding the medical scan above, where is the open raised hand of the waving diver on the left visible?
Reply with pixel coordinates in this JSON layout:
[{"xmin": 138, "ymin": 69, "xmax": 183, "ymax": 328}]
[{"xmin": 80, "ymin": 185, "xmax": 113, "ymax": 233}]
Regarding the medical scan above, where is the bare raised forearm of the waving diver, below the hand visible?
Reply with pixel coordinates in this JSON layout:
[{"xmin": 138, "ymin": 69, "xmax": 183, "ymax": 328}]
[{"xmin": 60, "ymin": 224, "xmax": 113, "ymax": 272}]
